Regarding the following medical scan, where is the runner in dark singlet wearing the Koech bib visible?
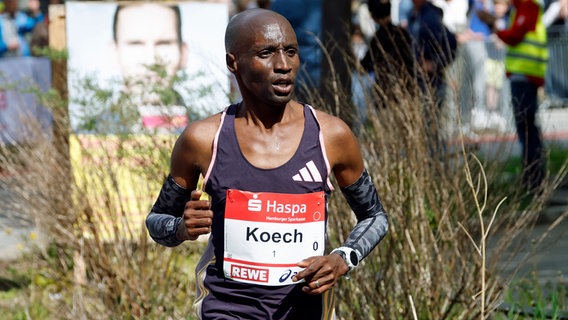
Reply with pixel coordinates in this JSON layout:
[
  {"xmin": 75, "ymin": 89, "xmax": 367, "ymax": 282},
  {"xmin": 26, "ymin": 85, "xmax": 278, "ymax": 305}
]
[{"xmin": 146, "ymin": 9, "xmax": 388, "ymax": 319}]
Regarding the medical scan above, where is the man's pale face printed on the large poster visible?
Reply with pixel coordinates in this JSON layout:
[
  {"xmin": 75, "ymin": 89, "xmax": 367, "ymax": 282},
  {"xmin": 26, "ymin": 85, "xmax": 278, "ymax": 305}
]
[{"xmin": 115, "ymin": 4, "xmax": 187, "ymax": 89}]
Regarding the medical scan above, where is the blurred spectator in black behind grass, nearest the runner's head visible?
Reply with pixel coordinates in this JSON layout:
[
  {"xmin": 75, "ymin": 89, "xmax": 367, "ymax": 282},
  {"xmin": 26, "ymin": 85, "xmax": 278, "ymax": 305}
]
[{"xmin": 361, "ymin": 0, "xmax": 415, "ymax": 107}]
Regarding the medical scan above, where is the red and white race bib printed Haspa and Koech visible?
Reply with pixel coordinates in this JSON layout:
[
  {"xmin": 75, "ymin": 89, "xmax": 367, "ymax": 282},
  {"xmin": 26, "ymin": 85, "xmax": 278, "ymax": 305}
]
[{"xmin": 223, "ymin": 189, "xmax": 325, "ymax": 286}]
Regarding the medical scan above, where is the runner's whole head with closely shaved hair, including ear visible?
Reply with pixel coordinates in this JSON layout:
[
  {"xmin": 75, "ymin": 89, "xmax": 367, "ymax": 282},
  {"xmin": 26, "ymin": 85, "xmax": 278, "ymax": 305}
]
[{"xmin": 225, "ymin": 9, "xmax": 300, "ymax": 108}]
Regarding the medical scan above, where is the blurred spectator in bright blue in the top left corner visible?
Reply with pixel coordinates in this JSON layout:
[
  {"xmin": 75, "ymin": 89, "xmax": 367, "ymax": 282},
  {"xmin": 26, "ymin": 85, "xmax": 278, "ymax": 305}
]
[{"xmin": 0, "ymin": 0, "xmax": 44, "ymax": 57}]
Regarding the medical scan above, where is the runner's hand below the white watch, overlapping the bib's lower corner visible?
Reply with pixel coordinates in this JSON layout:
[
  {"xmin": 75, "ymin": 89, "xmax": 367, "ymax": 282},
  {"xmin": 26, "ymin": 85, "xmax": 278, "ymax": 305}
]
[{"xmin": 292, "ymin": 253, "xmax": 349, "ymax": 294}]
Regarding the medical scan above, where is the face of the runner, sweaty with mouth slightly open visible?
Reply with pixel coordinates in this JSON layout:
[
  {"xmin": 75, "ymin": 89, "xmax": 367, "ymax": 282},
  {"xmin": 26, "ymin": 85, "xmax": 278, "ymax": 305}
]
[{"xmin": 229, "ymin": 19, "xmax": 300, "ymax": 104}]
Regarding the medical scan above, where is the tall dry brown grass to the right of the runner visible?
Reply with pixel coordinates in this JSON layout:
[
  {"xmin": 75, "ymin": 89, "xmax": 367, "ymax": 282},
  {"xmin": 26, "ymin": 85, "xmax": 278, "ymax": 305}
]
[{"xmin": 318, "ymin": 50, "xmax": 566, "ymax": 319}]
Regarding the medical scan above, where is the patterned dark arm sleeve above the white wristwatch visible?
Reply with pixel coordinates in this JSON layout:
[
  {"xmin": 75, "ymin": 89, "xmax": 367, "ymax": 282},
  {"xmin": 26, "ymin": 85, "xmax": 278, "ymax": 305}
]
[{"xmin": 341, "ymin": 170, "xmax": 388, "ymax": 260}]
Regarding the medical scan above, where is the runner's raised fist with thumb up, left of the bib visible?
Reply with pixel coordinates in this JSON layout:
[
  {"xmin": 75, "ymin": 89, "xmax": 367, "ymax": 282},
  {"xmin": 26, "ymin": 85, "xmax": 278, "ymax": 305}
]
[{"xmin": 176, "ymin": 190, "xmax": 213, "ymax": 241}]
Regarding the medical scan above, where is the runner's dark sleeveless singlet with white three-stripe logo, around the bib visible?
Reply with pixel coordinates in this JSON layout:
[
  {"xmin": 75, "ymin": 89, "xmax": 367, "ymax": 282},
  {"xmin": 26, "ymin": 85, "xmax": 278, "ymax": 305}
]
[{"xmin": 194, "ymin": 104, "xmax": 335, "ymax": 320}]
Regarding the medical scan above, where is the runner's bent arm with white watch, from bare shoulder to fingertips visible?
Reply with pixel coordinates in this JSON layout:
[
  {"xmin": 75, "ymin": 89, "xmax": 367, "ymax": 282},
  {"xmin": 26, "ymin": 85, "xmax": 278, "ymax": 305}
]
[{"xmin": 293, "ymin": 117, "xmax": 388, "ymax": 294}]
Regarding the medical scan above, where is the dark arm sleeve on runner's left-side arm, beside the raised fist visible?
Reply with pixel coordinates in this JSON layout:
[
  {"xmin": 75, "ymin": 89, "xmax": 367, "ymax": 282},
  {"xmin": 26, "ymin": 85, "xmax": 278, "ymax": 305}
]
[{"xmin": 146, "ymin": 175, "xmax": 191, "ymax": 247}]
